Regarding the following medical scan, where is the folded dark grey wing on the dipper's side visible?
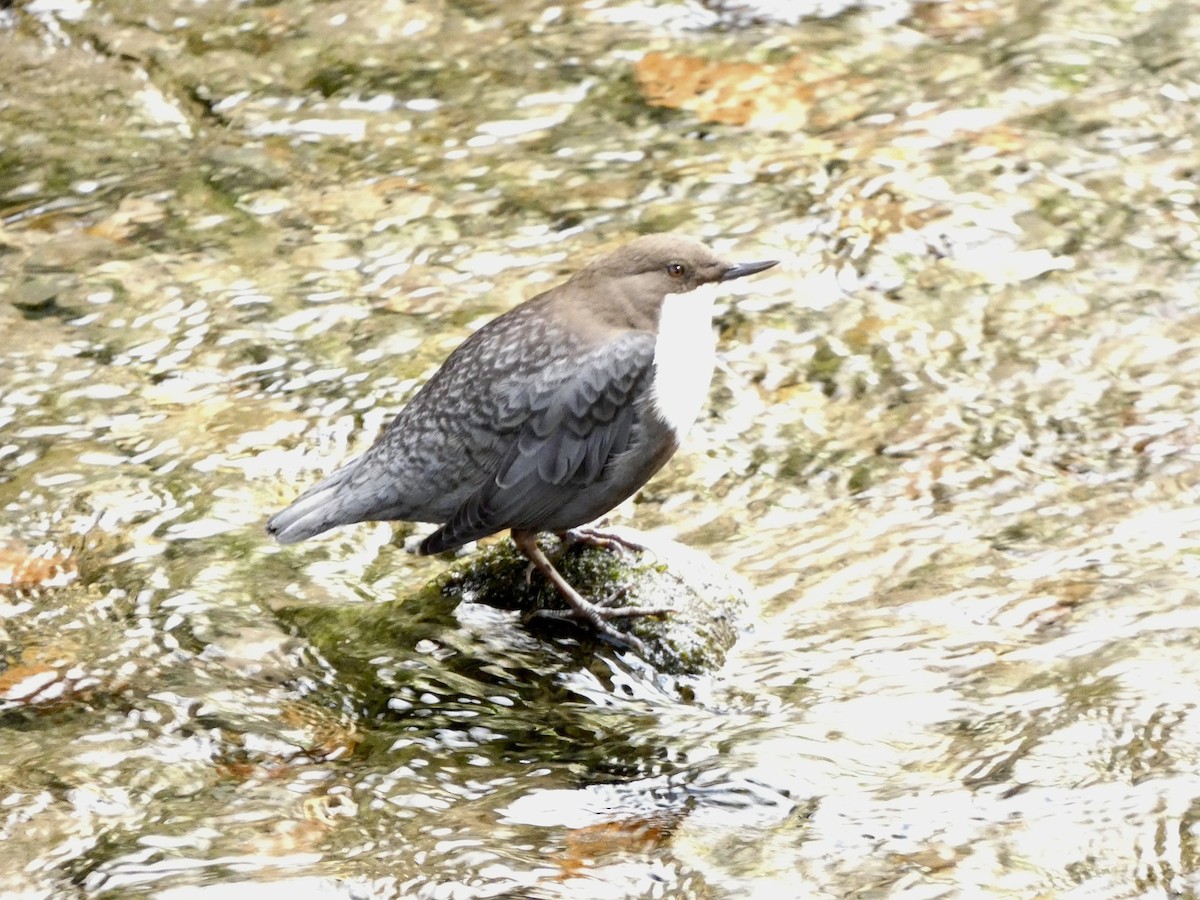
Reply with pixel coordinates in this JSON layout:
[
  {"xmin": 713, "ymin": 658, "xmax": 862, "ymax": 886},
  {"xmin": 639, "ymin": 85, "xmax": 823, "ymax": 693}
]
[{"xmin": 421, "ymin": 331, "xmax": 654, "ymax": 553}]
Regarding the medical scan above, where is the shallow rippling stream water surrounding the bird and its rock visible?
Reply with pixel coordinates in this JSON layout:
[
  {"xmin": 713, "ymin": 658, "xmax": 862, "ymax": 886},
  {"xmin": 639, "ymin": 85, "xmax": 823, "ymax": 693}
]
[{"xmin": 0, "ymin": 0, "xmax": 1200, "ymax": 900}]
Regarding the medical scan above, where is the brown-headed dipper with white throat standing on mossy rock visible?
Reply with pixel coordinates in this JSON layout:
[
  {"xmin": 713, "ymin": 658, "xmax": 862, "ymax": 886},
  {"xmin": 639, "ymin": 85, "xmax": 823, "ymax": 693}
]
[{"xmin": 266, "ymin": 234, "xmax": 776, "ymax": 649}]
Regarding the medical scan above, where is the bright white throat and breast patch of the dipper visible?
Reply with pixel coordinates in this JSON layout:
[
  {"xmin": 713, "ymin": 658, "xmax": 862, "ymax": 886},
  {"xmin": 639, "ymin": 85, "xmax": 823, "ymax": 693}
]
[{"xmin": 653, "ymin": 284, "xmax": 720, "ymax": 440}]
